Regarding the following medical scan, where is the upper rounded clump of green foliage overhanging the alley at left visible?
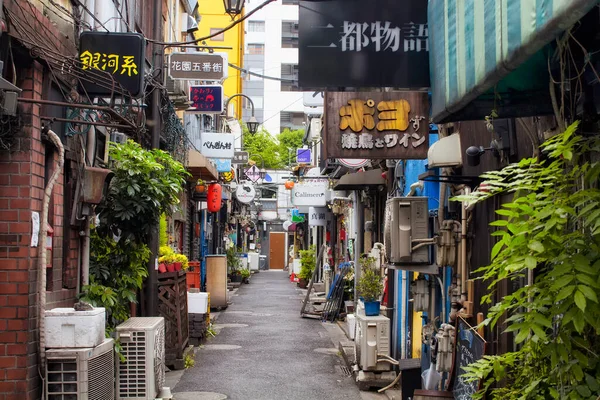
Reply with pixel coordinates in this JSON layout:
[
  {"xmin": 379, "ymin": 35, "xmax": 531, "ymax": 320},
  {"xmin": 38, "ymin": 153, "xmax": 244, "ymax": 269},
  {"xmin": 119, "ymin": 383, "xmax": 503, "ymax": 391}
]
[{"xmin": 96, "ymin": 140, "xmax": 189, "ymax": 242}]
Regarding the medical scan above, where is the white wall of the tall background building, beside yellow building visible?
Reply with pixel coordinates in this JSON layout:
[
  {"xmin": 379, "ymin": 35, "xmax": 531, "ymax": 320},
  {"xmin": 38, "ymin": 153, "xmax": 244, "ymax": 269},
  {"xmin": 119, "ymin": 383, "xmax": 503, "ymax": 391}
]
[{"xmin": 246, "ymin": 0, "xmax": 304, "ymax": 135}]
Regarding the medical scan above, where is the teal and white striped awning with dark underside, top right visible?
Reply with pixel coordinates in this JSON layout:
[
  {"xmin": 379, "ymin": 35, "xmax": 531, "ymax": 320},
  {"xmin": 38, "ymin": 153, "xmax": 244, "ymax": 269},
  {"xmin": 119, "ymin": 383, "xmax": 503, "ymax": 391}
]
[{"xmin": 428, "ymin": 0, "xmax": 598, "ymax": 123}]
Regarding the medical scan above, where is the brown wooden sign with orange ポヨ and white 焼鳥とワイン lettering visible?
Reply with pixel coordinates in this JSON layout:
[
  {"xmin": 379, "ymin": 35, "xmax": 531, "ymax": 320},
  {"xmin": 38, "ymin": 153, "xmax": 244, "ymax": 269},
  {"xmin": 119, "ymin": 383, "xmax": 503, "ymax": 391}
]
[{"xmin": 323, "ymin": 92, "xmax": 429, "ymax": 159}]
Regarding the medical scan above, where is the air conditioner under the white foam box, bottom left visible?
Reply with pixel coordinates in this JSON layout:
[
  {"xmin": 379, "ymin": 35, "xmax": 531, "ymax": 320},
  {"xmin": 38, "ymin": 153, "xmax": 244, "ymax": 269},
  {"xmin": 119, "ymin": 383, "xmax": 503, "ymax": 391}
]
[{"xmin": 45, "ymin": 339, "xmax": 115, "ymax": 400}]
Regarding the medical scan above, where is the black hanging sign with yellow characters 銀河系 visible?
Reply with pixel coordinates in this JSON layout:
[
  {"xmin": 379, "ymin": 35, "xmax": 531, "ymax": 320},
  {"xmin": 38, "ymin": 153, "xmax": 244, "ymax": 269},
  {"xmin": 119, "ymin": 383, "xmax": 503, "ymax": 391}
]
[{"xmin": 79, "ymin": 32, "xmax": 146, "ymax": 97}]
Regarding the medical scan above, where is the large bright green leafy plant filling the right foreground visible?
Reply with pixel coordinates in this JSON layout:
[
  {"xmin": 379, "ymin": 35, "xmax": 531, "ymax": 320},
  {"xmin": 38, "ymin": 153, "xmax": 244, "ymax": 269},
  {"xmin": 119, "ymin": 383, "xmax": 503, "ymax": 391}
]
[{"xmin": 457, "ymin": 124, "xmax": 600, "ymax": 399}]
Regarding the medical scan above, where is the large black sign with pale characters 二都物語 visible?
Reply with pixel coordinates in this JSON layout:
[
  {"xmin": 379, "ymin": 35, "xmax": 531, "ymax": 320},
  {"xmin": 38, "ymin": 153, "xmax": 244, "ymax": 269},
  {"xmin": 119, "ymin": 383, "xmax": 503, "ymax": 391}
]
[{"xmin": 298, "ymin": 0, "xmax": 429, "ymax": 91}]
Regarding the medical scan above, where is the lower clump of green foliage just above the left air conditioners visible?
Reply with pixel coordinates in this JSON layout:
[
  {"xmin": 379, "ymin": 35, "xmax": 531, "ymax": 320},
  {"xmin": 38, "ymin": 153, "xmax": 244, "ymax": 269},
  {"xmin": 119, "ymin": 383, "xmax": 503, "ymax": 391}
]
[{"xmin": 82, "ymin": 229, "xmax": 151, "ymax": 333}]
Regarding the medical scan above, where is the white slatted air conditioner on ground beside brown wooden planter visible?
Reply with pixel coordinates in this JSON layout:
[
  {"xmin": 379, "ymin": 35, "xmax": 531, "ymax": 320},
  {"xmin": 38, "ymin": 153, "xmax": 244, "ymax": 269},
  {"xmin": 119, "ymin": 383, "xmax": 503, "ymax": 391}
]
[{"xmin": 117, "ymin": 317, "xmax": 165, "ymax": 400}]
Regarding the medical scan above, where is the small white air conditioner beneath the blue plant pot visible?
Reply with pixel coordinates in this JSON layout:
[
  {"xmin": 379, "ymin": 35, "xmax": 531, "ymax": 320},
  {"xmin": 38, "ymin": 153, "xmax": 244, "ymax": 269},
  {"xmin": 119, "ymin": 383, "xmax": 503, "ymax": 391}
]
[{"xmin": 354, "ymin": 311, "xmax": 391, "ymax": 371}]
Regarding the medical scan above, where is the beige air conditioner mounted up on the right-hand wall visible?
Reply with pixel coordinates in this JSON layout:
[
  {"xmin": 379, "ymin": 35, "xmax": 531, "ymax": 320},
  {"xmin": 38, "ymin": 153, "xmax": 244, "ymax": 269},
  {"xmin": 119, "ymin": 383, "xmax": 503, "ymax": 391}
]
[{"xmin": 384, "ymin": 197, "xmax": 429, "ymax": 267}]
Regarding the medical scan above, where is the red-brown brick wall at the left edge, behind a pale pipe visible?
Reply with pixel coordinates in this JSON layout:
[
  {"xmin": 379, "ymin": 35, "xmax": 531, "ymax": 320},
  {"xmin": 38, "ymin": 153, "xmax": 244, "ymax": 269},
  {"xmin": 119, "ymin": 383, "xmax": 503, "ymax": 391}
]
[{"xmin": 0, "ymin": 0, "xmax": 79, "ymax": 400}]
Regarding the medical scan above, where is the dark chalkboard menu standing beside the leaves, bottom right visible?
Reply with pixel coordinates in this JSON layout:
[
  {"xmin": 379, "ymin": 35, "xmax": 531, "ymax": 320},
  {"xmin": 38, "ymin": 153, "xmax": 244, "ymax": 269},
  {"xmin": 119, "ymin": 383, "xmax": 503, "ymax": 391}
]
[{"xmin": 452, "ymin": 317, "xmax": 486, "ymax": 400}]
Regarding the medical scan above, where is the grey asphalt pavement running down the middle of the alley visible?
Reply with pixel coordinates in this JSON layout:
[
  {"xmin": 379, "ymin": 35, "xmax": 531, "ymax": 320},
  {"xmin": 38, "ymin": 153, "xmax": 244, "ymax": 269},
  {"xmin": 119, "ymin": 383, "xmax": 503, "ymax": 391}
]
[{"xmin": 172, "ymin": 271, "xmax": 387, "ymax": 400}]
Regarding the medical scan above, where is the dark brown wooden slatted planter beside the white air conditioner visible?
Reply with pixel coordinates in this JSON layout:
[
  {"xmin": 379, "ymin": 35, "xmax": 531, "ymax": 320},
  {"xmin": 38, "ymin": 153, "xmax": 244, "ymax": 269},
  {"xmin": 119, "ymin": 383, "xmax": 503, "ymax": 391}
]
[{"xmin": 158, "ymin": 271, "xmax": 189, "ymax": 369}]
